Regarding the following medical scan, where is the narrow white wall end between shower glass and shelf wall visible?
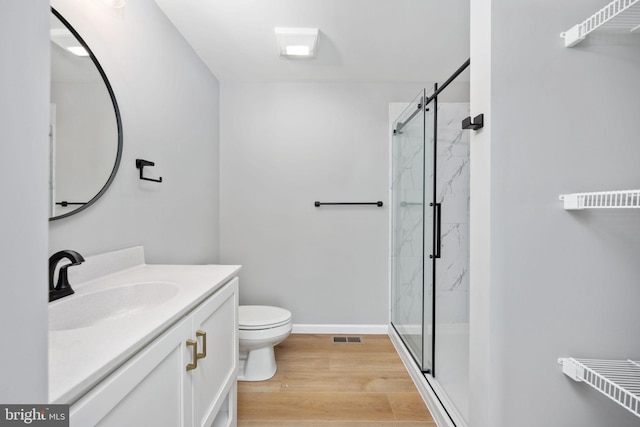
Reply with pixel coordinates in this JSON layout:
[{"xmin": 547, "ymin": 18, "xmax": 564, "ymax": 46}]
[{"xmin": 468, "ymin": 0, "xmax": 492, "ymax": 427}]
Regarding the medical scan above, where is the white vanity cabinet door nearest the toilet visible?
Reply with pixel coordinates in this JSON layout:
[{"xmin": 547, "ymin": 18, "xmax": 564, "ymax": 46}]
[{"xmin": 189, "ymin": 278, "xmax": 238, "ymax": 426}]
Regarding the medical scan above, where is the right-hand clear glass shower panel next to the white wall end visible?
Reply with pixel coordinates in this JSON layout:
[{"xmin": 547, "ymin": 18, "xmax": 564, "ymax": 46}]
[{"xmin": 434, "ymin": 69, "xmax": 471, "ymax": 420}]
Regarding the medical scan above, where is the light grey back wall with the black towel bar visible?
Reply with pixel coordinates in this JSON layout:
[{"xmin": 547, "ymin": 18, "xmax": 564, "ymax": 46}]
[{"xmin": 220, "ymin": 83, "xmax": 436, "ymax": 325}]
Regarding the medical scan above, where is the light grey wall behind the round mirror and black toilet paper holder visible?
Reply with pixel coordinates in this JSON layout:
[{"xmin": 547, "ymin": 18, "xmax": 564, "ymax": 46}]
[{"xmin": 49, "ymin": 0, "xmax": 219, "ymax": 263}]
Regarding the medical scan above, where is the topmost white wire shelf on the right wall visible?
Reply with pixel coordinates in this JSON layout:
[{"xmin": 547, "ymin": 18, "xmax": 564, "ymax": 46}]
[{"xmin": 560, "ymin": 0, "xmax": 640, "ymax": 47}]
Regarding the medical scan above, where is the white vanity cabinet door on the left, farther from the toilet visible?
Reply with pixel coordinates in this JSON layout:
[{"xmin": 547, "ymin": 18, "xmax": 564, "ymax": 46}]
[{"xmin": 70, "ymin": 318, "xmax": 193, "ymax": 427}]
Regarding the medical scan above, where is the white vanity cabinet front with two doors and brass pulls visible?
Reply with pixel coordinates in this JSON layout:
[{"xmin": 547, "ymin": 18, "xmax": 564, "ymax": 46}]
[{"xmin": 70, "ymin": 278, "xmax": 238, "ymax": 427}]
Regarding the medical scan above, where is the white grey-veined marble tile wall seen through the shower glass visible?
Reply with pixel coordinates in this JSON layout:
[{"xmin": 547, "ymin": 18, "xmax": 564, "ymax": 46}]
[{"xmin": 392, "ymin": 103, "xmax": 469, "ymax": 327}]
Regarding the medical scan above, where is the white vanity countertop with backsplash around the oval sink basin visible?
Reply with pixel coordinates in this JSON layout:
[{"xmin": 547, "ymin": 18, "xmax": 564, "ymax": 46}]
[{"xmin": 49, "ymin": 247, "xmax": 241, "ymax": 404}]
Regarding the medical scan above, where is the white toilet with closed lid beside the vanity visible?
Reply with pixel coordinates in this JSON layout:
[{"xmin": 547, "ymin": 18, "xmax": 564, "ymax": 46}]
[{"xmin": 238, "ymin": 305, "xmax": 291, "ymax": 381}]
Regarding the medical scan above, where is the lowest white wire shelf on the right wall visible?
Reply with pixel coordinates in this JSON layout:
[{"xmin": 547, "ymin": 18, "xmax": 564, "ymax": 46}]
[{"xmin": 558, "ymin": 357, "xmax": 640, "ymax": 417}]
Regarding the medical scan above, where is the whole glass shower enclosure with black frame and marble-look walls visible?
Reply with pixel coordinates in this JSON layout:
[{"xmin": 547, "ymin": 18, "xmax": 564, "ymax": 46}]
[{"xmin": 391, "ymin": 61, "xmax": 469, "ymax": 425}]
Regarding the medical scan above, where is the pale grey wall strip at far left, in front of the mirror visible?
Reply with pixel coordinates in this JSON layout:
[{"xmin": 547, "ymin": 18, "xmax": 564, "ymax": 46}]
[{"xmin": 0, "ymin": 0, "xmax": 49, "ymax": 404}]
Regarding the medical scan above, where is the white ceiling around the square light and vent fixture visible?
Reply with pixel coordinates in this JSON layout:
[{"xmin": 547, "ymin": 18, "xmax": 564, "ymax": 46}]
[{"xmin": 155, "ymin": 0, "xmax": 469, "ymax": 82}]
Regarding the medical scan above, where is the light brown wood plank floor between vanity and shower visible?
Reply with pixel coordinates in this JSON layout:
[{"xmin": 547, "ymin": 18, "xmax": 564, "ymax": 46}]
[{"xmin": 238, "ymin": 334, "xmax": 436, "ymax": 427}]
